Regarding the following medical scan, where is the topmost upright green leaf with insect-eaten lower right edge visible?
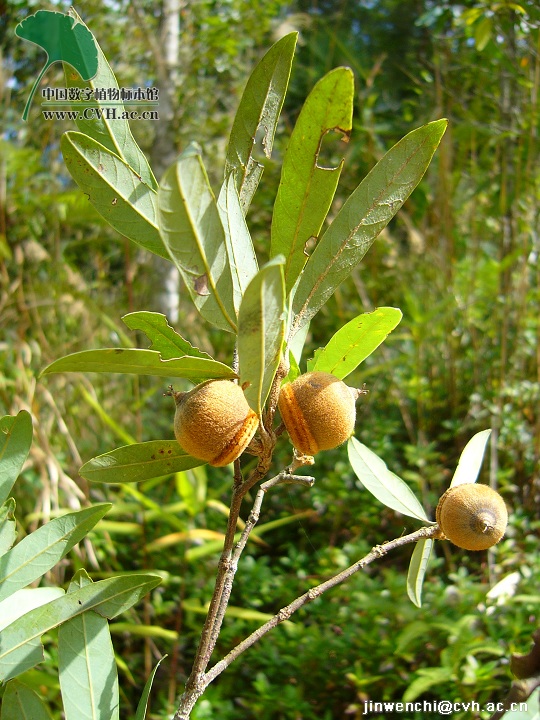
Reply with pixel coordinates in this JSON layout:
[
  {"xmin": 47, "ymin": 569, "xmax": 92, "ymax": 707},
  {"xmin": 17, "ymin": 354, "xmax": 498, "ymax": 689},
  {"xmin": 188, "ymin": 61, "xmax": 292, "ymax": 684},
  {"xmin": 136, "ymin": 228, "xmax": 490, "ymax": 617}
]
[{"xmin": 225, "ymin": 33, "xmax": 298, "ymax": 214}]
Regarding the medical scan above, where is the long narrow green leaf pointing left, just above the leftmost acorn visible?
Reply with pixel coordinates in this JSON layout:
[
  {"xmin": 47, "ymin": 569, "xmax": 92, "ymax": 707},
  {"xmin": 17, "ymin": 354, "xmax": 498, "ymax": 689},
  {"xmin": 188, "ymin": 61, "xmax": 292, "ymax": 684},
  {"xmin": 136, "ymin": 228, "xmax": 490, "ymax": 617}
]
[{"xmin": 41, "ymin": 348, "xmax": 236, "ymax": 380}]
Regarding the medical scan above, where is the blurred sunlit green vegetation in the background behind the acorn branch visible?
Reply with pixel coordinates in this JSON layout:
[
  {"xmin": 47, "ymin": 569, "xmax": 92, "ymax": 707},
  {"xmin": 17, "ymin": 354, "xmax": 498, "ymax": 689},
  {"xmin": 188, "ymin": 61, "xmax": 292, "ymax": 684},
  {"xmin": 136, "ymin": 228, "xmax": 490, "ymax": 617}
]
[{"xmin": 0, "ymin": 0, "xmax": 540, "ymax": 720}]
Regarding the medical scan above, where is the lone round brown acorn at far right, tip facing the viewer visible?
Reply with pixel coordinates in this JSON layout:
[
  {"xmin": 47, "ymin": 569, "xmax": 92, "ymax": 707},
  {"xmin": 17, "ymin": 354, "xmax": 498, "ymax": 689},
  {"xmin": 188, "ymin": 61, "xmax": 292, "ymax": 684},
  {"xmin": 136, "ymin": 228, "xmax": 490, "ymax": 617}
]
[{"xmin": 436, "ymin": 483, "xmax": 508, "ymax": 550}]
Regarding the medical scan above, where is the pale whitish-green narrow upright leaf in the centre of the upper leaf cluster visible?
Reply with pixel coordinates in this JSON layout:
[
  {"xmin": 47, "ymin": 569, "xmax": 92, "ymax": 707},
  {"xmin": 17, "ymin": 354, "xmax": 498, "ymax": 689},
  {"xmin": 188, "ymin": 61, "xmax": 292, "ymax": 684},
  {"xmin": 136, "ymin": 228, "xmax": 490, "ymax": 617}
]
[{"xmin": 217, "ymin": 175, "xmax": 259, "ymax": 313}]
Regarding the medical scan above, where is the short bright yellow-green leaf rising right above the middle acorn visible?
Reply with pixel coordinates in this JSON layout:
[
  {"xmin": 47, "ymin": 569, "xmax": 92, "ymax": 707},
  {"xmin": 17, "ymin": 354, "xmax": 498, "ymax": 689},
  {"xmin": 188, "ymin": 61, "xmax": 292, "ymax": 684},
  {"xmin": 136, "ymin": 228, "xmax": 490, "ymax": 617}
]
[{"xmin": 308, "ymin": 307, "xmax": 403, "ymax": 380}]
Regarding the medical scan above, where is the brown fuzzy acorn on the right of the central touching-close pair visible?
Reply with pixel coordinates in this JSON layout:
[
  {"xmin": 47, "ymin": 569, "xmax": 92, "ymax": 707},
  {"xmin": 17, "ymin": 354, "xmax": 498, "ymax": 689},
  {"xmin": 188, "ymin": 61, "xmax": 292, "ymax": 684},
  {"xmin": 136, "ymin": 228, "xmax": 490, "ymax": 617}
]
[{"xmin": 278, "ymin": 371, "xmax": 365, "ymax": 455}]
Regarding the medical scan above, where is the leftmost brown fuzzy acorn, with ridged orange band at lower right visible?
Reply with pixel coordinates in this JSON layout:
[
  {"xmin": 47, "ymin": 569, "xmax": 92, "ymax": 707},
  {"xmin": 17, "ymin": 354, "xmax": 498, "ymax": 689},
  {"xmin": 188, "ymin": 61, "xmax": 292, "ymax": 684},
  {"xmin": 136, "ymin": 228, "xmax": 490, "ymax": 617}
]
[{"xmin": 171, "ymin": 380, "xmax": 259, "ymax": 467}]
